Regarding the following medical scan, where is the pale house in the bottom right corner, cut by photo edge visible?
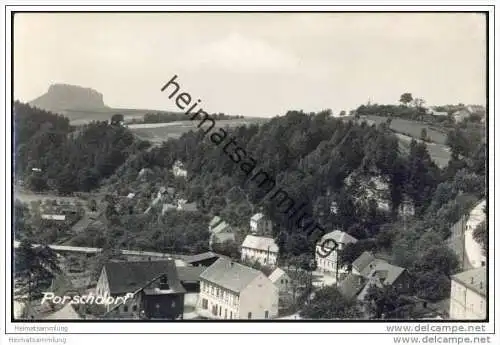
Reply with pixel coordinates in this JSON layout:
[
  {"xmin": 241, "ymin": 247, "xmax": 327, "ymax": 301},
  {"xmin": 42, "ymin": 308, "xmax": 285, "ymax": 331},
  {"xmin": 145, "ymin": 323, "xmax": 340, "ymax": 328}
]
[{"xmin": 450, "ymin": 267, "xmax": 488, "ymax": 320}]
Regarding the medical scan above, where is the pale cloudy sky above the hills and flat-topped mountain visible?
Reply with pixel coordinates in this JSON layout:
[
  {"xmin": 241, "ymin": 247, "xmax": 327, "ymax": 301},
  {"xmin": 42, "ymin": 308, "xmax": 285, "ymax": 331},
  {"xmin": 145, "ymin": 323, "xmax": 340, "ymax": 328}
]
[{"xmin": 14, "ymin": 13, "xmax": 486, "ymax": 117}]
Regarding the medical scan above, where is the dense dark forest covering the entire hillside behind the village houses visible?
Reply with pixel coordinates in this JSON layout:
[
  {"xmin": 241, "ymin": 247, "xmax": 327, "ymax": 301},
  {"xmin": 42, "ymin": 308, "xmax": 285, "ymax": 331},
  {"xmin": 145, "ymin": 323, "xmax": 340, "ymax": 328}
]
[{"xmin": 15, "ymin": 103, "xmax": 487, "ymax": 313}]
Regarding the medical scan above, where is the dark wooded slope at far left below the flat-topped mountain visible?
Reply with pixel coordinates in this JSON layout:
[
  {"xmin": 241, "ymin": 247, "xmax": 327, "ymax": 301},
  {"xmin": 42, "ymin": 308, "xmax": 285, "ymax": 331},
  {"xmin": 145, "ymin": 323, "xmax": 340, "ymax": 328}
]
[{"xmin": 13, "ymin": 102, "xmax": 149, "ymax": 194}]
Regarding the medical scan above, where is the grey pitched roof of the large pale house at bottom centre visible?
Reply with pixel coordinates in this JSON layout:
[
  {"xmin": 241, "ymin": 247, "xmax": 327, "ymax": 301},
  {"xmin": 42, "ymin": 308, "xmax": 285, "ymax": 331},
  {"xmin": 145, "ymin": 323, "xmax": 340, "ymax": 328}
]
[{"xmin": 201, "ymin": 258, "xmax": 263, "ymax": 292}]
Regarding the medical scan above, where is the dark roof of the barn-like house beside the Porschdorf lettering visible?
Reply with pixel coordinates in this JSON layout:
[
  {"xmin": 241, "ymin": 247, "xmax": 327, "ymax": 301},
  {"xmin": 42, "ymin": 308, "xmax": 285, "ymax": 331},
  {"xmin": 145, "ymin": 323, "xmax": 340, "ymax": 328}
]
[{"xmin": 104, "ymin": 260, "xmax": 185, "ymax": 295}]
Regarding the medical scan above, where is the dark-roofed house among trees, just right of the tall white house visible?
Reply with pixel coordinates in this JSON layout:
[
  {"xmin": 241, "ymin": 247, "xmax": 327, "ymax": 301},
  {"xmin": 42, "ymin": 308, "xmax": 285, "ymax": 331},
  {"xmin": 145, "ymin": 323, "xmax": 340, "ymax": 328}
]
[{"xmin": 339, "ymin": 252, "xmax": 410, "ymax": 303}]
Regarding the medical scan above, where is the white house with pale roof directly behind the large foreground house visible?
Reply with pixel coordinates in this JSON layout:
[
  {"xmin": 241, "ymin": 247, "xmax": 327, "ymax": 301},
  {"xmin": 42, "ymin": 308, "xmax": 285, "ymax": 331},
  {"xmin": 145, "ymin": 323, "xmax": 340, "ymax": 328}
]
[{"xmin": 241, "ymin": 235, "xmax": 279, "ymax": 266}]
